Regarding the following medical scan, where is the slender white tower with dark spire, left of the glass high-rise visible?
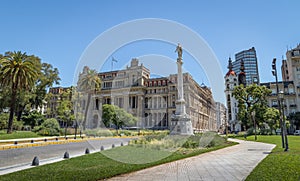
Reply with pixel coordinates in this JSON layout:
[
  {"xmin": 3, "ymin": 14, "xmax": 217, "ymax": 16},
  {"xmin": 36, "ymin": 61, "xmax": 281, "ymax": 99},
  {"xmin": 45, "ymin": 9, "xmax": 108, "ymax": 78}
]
[{"xmin": 224, "ymin": 57, "xmax": 241, "ymax": 131}]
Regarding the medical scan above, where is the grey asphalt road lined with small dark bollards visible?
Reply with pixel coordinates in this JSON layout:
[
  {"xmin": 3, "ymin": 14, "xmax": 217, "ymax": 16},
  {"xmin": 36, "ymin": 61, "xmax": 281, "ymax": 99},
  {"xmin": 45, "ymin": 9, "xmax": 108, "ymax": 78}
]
[{"xmin": 0, "ymin": 138, "xmax": 131, "ymax": 171}]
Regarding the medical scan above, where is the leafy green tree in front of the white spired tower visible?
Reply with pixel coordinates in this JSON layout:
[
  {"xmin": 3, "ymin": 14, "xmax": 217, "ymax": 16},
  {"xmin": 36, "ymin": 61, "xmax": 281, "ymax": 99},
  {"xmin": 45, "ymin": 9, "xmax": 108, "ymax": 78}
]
[{"xmin": 232, "ymin": 84, "xmax": 271, "ymax": 132}]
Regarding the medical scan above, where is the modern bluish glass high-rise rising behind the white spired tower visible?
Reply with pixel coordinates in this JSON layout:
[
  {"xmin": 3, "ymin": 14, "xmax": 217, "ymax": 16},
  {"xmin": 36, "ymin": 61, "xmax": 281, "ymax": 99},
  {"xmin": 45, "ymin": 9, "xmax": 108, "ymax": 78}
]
[{"xmin": 232, "ymin": 47, "xmax": 259, "ymax": 85}]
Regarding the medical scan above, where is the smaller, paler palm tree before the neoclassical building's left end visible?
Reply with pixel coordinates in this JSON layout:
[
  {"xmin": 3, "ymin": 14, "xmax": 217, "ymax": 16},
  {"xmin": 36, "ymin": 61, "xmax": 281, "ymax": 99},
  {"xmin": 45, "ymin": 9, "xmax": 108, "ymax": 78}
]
[{"xmin": 77, "ymin": 67, "xmax": 101, "ymax": 129}]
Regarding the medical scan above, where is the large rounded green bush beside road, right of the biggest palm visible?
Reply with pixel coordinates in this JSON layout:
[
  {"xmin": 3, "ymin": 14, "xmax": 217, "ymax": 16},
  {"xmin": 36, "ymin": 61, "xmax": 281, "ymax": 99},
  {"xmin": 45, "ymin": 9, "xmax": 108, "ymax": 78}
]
[{"xmin": 32, "ymin": 118, "xmax": 60, "ymax": 136}]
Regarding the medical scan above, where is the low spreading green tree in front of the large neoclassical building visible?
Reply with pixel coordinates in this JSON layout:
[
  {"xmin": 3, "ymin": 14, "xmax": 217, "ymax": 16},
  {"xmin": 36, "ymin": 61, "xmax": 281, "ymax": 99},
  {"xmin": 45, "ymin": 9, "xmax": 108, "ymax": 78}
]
[{"xmin": 102, "ymin": 104, "xmax": 137, "ymax": 131}]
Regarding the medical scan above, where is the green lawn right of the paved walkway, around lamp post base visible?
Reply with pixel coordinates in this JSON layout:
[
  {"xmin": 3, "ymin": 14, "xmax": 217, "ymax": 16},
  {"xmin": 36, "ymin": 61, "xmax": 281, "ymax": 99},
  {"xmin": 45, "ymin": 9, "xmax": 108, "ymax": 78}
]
[{"xmin": 246, "ymin": 135, "xmax": 300, "ymax": 181}]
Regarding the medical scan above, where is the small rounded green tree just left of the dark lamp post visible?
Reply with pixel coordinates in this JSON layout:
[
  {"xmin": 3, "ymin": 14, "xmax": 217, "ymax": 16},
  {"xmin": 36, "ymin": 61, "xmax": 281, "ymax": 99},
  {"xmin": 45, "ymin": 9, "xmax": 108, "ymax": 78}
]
[{"xmin": 264, "ymin": 108, "xmax": 280, "ymax": 134}]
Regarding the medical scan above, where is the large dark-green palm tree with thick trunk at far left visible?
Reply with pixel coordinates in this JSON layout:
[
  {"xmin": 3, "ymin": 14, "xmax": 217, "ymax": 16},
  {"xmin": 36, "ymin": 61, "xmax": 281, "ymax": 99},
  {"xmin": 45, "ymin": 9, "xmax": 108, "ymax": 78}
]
[{"xmin": 0, "ymin": 51, "xmax": 40, "ymax": 134}]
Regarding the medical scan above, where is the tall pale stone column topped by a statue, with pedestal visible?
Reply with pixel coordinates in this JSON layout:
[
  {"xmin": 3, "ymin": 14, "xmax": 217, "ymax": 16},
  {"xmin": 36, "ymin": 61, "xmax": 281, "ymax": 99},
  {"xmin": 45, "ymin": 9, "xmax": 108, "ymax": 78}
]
[{"xmin": 170, "ymin": 44, "xmax": 193, "ymax": 135}]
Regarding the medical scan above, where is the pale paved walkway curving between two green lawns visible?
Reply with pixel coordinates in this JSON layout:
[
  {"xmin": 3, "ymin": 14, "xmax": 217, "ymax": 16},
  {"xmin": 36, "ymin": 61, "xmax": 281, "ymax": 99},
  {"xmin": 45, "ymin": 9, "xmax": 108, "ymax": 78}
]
[{"xmin": 110, "ymin": 139, "xmax": 275, "ymax": 181}]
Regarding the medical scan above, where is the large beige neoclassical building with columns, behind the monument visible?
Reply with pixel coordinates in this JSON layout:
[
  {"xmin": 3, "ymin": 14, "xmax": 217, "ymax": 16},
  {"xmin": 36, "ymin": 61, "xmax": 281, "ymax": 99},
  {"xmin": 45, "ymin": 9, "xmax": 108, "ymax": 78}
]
[{"xmin": 79, "ymin": 58, "xmax": 217, "ymax": 132}]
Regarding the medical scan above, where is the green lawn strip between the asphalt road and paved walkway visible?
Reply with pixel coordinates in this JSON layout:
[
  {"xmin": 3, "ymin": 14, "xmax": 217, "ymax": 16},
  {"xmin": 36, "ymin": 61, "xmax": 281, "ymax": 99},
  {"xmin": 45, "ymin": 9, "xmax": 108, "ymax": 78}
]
[{"xmin": 0, "ymin": 136, "xmax": 235, "ymax": 181}]
